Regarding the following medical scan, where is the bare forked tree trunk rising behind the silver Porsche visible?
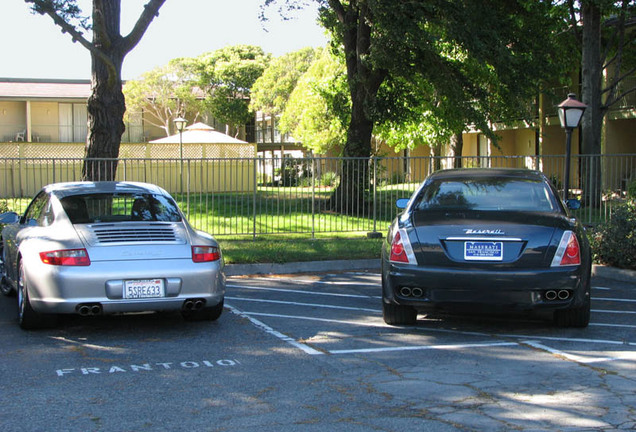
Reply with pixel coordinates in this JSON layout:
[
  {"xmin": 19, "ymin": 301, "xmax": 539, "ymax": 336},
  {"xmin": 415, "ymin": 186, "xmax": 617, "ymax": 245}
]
[{"xmin": 25, "ymin": 0, "xmax": 166, "ymax": 180}]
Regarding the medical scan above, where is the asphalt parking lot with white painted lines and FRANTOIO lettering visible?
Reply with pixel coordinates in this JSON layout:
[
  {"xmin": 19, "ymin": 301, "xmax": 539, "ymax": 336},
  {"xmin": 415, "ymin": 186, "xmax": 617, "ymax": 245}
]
[{"xmin": 0, "ymin": 271, "xmax": 636, "ymax": 431}]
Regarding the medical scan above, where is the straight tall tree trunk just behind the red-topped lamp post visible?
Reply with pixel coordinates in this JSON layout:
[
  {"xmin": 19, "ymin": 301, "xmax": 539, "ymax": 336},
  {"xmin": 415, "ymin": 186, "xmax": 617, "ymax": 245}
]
[{"xmin": 580, "ymin": 1, "xmax": 603, "ymax": 207}]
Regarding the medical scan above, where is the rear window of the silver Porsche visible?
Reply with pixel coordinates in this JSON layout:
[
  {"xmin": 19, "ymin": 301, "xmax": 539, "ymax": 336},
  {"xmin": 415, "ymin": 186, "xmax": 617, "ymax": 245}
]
[{"xmin": 61, "ymin": 193, "xmax": 181, "ymax": 224}]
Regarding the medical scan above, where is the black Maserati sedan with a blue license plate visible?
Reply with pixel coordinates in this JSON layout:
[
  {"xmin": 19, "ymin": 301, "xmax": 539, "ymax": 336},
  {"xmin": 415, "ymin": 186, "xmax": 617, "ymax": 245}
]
[{"xmin": 382, "ymin": 168, "xmax": 591, "ymax": 327}]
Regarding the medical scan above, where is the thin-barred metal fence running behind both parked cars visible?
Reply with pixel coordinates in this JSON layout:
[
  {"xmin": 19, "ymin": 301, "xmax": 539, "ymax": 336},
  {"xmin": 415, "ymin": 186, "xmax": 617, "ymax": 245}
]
[{"xmin": 0, "ymin": 154, "xmax": 636, "ymax": 236}]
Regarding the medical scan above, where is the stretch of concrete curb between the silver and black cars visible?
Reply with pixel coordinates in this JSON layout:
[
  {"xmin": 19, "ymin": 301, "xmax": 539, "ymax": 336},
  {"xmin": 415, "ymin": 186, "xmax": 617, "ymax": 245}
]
[{"xmin": 225, "ymin": 259, "xmax": 380, "ymax": 276}]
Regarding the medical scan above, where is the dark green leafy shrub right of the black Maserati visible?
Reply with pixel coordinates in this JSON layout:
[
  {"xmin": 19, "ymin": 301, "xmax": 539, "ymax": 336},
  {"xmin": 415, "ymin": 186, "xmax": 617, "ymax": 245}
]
[{"xmin": 590, "ymin": 199, "xmax": 636, "ymax": 270}]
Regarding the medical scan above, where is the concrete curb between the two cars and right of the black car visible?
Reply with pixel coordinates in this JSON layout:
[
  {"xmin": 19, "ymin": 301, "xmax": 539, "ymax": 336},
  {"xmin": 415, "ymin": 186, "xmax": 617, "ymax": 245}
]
[{"xmin": 225, "ymin": 259, "xmax": 636, "ymax": 284}]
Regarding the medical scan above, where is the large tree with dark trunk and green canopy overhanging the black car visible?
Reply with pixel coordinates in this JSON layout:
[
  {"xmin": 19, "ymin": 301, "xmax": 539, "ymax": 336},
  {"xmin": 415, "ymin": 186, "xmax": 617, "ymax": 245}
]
[{"xmin": 265, "ymin": 0, "xmax": 564, "ymax": 211}]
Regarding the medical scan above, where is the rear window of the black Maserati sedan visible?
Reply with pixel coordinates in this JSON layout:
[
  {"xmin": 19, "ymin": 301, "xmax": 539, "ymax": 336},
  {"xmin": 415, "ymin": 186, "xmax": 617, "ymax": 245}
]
[{"xmin": 415, "ymin": 178, "xmax": 559, "ymax": 212}]
